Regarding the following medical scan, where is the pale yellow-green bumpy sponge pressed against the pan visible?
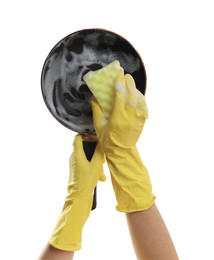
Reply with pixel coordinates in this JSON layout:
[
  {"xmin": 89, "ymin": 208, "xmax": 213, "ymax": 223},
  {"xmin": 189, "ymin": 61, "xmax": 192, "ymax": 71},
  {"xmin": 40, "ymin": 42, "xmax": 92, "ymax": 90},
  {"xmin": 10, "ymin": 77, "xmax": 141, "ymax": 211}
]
[{"xmin": 83, "ymin": 60, "xmax": 124, "ymax": 119}]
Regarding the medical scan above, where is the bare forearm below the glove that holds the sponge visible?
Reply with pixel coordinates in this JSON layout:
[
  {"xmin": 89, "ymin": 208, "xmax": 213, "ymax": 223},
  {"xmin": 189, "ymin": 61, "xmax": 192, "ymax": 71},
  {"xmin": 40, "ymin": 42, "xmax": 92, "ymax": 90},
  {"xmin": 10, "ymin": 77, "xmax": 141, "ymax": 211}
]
[{"xmin": 126, "ymin": 204, "xmax": 178, "ymax": 260}]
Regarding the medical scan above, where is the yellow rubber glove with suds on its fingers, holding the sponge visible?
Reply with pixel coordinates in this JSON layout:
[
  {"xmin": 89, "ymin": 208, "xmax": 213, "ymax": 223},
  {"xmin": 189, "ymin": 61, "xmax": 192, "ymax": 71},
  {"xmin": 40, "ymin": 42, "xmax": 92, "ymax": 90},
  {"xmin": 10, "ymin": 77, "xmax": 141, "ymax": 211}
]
[{"xmin": 92, "ymin": 74, "xmax": 155, "ymax": 212}]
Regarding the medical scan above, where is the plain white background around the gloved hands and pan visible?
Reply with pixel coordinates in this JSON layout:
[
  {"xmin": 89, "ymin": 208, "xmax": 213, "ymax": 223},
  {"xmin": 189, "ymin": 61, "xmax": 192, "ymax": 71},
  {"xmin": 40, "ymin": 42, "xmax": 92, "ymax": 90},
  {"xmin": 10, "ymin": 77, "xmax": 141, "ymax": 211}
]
[{"xmin": 0, "ymin": 0, "xmax": 214, "ymax": 260}]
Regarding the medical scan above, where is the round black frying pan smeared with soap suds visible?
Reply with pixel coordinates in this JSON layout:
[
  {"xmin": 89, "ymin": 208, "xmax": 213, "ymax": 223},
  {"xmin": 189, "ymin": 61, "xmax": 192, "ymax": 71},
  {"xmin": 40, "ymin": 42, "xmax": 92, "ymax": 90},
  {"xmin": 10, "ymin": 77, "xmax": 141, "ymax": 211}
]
[{"xmin": 41, "ymin": 29, "xmax": 146, "ymax": 209}]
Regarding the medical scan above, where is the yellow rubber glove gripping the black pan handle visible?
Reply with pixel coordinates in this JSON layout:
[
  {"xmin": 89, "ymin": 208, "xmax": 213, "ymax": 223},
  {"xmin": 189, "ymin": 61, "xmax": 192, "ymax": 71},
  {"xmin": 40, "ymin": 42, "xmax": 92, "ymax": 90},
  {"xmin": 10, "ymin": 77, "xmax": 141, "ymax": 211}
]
[{"xmin": 49, "ymin": 134, "xmax": 105, "ymax": 251}]
